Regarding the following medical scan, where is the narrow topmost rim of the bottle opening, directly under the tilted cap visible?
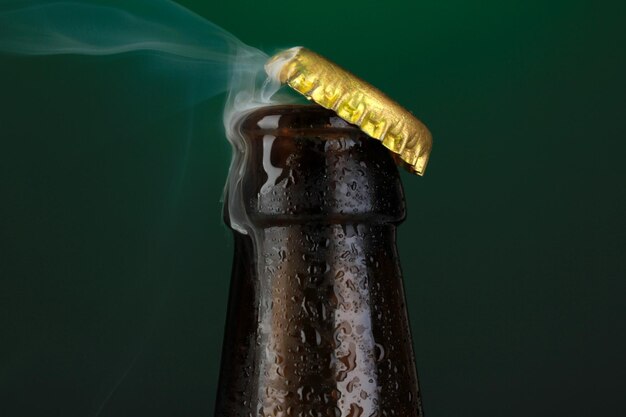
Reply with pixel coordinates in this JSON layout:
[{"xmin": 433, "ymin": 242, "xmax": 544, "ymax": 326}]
[{"xmin": 239, "ymin": 104, "xmax": 366, "ymax": 136}]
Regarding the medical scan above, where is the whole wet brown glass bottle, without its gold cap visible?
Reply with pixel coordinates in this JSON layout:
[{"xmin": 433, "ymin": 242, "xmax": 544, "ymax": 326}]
[{"xmin": 216, "ymin": 106, "xmax": 422, "ymax": 417}]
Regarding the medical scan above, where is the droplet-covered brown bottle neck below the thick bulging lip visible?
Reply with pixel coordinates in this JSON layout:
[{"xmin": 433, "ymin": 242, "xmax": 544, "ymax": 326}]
[{"xmin": 219, "ymin": 219, "xmax": 421, "ymax": 417}]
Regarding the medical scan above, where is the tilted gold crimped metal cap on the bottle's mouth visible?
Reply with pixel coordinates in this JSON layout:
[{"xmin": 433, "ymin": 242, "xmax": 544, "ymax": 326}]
[{"xmin": 265, "ymin": 47, "xmax": 432, "ymax": 175}]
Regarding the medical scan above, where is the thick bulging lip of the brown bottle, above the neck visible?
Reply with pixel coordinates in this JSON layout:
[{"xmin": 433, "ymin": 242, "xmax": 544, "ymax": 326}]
[{"xmin": 231, "ymin": 105, "xmax": 405, "ymax": 230}]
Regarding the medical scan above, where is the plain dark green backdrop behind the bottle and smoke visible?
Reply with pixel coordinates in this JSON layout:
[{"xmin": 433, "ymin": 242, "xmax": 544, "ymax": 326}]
[{"xmin": 0, "ymin": 0, "xmax": 626, "ymax": 417}]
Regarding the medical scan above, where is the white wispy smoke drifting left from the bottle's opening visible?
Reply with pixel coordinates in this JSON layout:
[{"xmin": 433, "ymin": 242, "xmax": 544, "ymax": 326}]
[{"xmin": 0, "ymin": 0, "xmax": 302, "ymax": 233}]
